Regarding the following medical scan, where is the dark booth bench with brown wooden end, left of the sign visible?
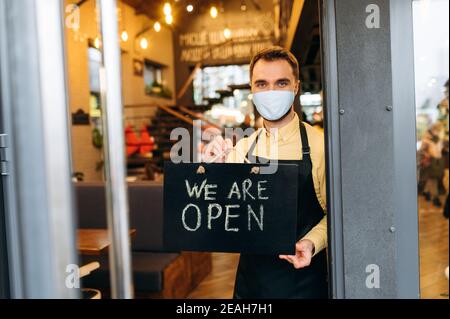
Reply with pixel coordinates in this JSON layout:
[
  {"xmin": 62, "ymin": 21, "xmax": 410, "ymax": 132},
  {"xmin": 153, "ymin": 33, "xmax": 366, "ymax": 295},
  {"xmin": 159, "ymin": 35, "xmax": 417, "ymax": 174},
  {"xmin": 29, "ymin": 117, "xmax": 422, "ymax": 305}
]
[{"xmin": 74, "ymin": 182, "xmax": 212, "ymax": 298}]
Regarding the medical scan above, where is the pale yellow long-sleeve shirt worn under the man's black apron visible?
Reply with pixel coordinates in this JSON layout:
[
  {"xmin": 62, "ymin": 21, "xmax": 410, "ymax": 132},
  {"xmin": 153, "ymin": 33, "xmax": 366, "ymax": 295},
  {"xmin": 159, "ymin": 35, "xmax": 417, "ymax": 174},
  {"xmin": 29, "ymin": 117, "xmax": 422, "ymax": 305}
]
[{"xmin": 227, "ymin": 114, "xmax": 327, "ymax": 254}]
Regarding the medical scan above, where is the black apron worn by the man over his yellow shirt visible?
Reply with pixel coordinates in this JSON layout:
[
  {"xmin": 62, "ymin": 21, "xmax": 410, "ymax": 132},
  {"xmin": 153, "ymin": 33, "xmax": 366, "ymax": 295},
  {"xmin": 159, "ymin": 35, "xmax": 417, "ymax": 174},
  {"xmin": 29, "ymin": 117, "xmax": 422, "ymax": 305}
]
[{"xmin": 233, "ymin": 121, "xmax": 328, "ymax": 299}]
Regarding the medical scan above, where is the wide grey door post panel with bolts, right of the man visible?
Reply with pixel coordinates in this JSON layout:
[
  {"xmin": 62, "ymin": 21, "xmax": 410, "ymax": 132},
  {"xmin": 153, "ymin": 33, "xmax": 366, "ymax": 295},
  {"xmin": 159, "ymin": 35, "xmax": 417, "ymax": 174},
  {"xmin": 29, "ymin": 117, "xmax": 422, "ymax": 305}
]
[{"xmin": 335, "ymin": 0, "xmax": 396, "ymax": 298}]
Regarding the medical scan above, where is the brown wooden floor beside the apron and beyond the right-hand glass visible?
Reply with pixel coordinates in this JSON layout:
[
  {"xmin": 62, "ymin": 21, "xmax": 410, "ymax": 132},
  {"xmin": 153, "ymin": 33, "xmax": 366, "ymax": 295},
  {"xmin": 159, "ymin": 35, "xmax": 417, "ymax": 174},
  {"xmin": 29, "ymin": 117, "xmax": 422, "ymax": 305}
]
[{"xmin": 188, "ymin": 197, "xmax": 449, "ymax": 299}]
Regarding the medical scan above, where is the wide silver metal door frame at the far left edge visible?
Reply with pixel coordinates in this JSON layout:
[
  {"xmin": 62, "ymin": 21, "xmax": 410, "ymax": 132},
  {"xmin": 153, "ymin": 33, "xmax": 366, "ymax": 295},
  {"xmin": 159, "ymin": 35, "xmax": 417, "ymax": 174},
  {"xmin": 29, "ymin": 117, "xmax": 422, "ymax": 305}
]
[{"xmin": 0, "ymin": 0, "xmax": 79, "ymax": 298}]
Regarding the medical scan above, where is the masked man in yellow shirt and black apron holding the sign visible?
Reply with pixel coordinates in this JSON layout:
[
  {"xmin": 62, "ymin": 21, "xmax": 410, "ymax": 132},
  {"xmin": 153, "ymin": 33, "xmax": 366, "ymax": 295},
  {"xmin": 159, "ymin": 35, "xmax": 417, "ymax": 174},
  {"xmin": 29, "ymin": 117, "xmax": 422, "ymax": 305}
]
[{"xmin": 204, "ymin": 47, "xmax": 328, "ymax": 298}]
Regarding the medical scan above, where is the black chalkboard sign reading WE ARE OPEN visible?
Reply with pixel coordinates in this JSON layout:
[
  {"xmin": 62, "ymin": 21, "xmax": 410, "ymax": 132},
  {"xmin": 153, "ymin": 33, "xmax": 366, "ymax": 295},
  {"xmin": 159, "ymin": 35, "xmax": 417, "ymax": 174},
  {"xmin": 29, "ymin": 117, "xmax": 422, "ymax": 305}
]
[{"xmin": 164, "ymin": 162, "xmax": 298, "ymax": 254}]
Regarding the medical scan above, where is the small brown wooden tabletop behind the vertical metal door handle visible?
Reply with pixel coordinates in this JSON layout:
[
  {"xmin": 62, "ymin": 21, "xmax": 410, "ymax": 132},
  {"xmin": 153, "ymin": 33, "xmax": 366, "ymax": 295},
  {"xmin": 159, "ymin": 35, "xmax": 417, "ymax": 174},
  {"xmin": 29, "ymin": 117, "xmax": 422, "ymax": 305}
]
[{"xmin": 77, "ymin": 229, "xmax": 136, "ymax": 255}]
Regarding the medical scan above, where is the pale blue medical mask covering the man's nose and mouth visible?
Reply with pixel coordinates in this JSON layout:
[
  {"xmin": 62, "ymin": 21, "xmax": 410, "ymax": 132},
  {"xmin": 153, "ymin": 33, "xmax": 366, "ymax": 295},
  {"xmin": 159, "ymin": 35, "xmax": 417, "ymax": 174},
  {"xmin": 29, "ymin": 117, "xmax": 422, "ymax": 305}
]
[{"xmin": 253, "ymin": 90, "xmax": 295, "ymax": 121}]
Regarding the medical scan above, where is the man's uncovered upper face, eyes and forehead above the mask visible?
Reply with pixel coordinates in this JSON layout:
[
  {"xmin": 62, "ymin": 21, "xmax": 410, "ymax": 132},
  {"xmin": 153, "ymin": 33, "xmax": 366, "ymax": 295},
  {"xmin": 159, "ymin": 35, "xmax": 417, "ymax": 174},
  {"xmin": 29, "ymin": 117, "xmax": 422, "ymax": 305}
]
[{"xmin": 251, "ymin": 59, "xmax": 300, "ymax": 95}]
